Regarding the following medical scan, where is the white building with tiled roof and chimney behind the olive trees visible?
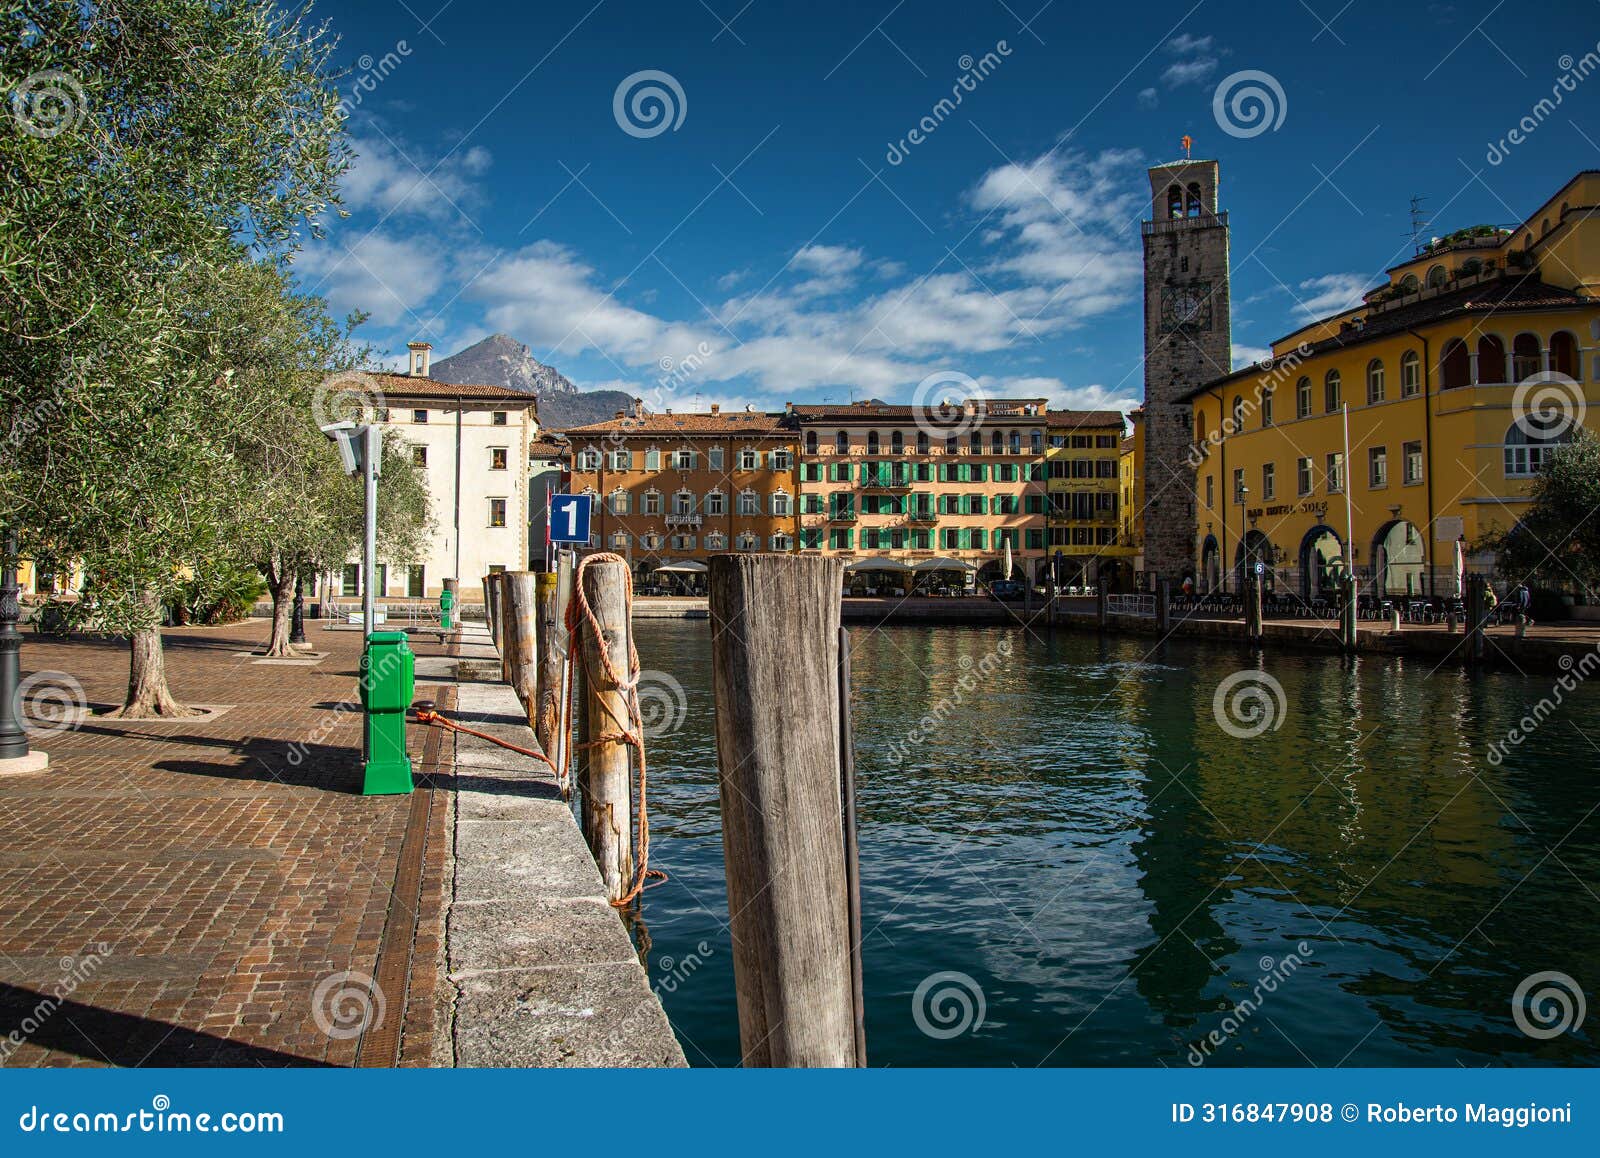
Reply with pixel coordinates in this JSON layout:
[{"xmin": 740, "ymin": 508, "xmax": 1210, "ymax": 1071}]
[{"xmin": 333, "ymin": 342, "xmax": 539, "ymax": 601}]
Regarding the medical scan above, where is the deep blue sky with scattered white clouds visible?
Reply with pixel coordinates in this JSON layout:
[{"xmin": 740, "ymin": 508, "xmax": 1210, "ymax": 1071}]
[{"xmin": 298, "ymin": 0, "xmax": 1600, "ymax": 408}]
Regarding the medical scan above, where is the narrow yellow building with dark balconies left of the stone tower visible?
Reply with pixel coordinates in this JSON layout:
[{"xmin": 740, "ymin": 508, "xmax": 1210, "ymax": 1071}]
[{"xmin": 1045, "ymin": 409, "xmax": 1134, "ymax": 590}]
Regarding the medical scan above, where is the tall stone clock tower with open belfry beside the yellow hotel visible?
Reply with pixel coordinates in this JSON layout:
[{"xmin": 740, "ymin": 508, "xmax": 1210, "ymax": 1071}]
[{"xmin": 1142, "ymin": 160, "xmax": 1232, "ymax": 587}]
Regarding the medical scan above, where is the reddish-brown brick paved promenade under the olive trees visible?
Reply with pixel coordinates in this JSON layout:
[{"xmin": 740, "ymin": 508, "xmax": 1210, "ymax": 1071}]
[{"xmin": 0, "ymin": 621, "xmax": 450, "ymax": 1065}]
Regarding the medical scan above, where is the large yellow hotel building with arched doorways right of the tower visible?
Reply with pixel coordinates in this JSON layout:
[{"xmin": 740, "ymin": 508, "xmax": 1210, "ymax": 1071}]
[{"xmin": 1190, "ymin": 171, "xmax": 1600, "ymax": 598}]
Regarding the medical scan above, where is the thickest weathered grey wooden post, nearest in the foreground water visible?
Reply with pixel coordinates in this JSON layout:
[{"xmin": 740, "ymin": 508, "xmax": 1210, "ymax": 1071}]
[{"xmin": 709, "ymin": 555, "xmax": 856, "ymax": 1067}]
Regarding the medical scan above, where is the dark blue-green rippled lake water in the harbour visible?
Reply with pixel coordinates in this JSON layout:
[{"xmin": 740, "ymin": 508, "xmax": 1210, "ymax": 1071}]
[{"xmin": 620, "ymin": 621, "xmax": 1600, "ymax": 1067}]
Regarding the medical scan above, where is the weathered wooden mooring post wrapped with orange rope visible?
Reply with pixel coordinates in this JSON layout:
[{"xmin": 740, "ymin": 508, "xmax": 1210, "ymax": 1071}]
[{"xmin": 578, "ymin": 560, "xmax": 634, "ymax": 900}]
